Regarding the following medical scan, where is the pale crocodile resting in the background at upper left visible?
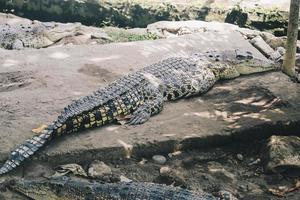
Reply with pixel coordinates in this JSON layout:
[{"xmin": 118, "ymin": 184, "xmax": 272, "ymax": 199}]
[{"xmin": 0, "ymin": 21, "xmax": 109, "ymax": 49}]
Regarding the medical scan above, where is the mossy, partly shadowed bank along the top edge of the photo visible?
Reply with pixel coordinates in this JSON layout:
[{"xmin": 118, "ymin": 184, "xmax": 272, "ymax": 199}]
[{"xmin": 0, "ymin": 0, "xmax": 288, "ymax": 32}]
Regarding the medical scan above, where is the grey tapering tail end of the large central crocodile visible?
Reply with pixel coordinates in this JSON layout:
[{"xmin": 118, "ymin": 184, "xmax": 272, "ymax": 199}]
[{"xmin": 0, "ymin": 126, "xmax": 55, "ymax": 175}]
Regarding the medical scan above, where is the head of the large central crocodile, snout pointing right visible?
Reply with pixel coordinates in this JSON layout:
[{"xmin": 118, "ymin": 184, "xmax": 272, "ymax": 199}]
[{"xmin": 196, "ymin": 50, "xmax": 279, "ymax": 79}]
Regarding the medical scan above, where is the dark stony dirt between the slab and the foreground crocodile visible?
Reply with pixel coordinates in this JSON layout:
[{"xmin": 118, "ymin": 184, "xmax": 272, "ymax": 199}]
[{"xmin": 0, "ymin": 140, "xmax": 300, "ymax": 200}]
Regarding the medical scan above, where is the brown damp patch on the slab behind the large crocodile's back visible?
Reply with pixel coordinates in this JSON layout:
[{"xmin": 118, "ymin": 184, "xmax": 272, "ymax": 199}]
[{"xmin": 78, "ymin": 64, "xmax": 121, "ymax": 82}]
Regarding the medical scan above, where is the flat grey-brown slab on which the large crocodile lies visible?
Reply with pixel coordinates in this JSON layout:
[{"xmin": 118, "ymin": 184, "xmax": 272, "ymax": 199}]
[{"xmin": 0, "ymin": 28, "xmax": 300, "ymax": 199}]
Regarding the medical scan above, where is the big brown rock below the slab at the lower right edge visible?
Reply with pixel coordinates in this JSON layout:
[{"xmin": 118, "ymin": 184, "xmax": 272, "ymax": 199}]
[{"xmin": 263, "ymin": 135, "xmax": 300, "ymax": 173}]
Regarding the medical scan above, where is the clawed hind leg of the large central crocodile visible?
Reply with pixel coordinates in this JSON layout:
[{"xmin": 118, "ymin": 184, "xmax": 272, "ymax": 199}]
[{"xmin": 128, "ymin": 85, "xmax": 164, "ymax": 125}]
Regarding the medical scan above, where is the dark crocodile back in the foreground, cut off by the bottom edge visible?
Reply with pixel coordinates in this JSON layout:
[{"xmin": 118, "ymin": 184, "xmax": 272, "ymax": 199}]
[{"xmin": 1, "ymin": 177, "xmax": 235, "ymax": 200}]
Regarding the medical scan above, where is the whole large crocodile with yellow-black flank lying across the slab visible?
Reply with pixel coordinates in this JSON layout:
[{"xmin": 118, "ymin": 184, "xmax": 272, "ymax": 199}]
[{"xmin": 0, "ymin": 50, "xmax": 277, "ymax": 175}]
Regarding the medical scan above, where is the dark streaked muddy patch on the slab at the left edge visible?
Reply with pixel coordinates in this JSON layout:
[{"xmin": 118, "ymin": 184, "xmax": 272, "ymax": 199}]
[{"xmin": 0, "ymin": 71, "xmax": 34, "ymax": 92}]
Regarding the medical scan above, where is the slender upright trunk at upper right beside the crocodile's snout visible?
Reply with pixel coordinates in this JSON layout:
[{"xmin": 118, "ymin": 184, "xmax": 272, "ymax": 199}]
[{"xmin": 283, "ymin": 0, "xmax": 300, "ymax": 77}]
